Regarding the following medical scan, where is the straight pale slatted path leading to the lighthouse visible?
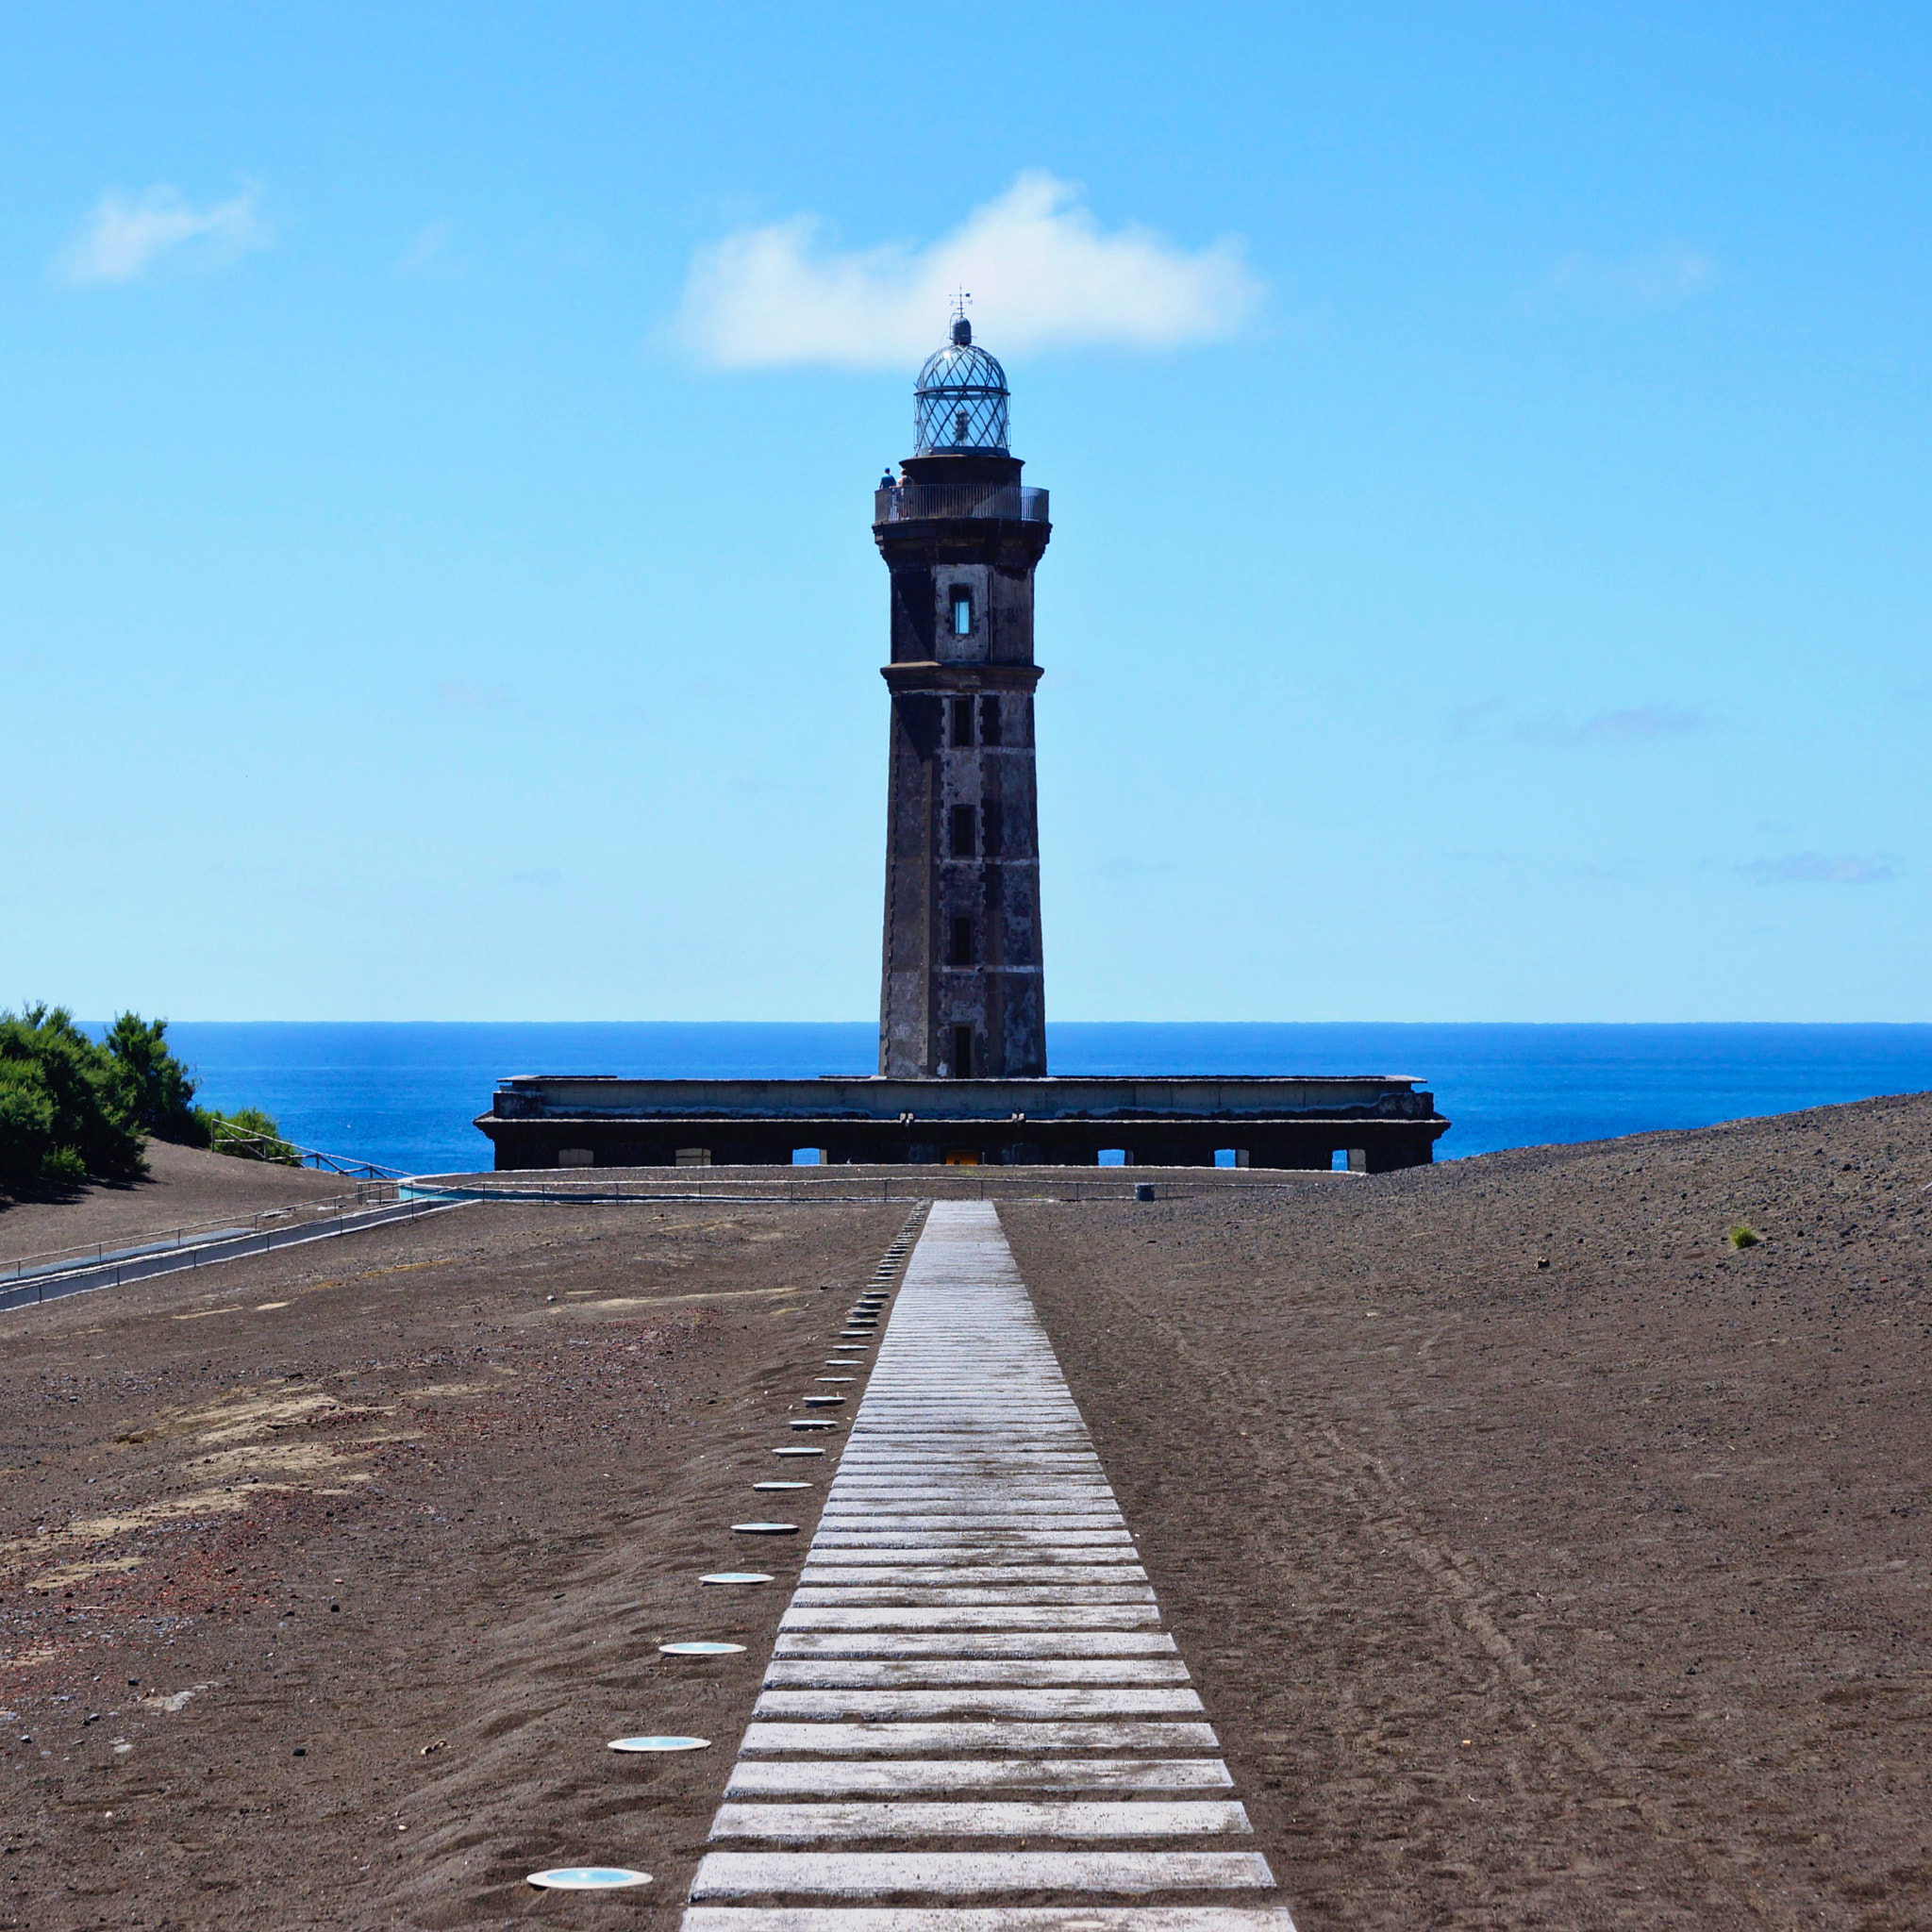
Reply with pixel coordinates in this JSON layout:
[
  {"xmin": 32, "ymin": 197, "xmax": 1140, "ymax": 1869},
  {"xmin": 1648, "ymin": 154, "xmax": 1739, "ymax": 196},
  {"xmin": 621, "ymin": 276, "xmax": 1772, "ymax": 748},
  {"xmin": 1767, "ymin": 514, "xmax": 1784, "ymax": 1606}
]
[{"xmin": 684, "ymin": 1202, "xmax": 1294, "ymax": 1932}]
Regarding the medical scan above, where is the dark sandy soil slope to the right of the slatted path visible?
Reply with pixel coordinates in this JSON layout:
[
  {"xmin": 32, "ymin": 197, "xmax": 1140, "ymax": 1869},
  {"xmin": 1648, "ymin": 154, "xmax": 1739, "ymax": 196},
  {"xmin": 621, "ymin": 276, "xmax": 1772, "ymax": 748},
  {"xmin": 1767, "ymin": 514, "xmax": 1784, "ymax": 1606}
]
[{"xmin": 1001, "ymin": 1097, "xmax": 1932, "ymax": 1932}]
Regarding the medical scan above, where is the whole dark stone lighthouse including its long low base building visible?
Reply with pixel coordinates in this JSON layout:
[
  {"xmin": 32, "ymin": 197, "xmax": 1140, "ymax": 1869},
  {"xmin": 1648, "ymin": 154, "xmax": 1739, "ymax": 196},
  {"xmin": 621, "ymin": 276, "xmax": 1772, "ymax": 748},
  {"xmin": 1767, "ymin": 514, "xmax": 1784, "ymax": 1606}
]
[{"xmin": 475, "ymin": 315, "xmax": 1449, "ymax": 1173}]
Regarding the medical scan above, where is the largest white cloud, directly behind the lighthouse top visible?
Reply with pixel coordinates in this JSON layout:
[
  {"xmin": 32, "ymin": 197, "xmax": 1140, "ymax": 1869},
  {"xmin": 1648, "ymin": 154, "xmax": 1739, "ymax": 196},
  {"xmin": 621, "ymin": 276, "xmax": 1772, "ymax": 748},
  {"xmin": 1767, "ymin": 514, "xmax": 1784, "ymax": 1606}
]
[{"xmin": 676, "ymin": 174, "xmax": 1263, "ymax": 369}]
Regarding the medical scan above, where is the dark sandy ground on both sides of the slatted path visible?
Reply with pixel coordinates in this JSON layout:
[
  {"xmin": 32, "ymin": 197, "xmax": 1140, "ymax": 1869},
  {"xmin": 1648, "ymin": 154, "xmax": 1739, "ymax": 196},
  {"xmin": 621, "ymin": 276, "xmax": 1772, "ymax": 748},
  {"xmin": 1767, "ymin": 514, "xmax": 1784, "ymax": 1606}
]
[{"xmin": 0, "ymin": 1099, "xmax": 1932, "ymax": 1932}]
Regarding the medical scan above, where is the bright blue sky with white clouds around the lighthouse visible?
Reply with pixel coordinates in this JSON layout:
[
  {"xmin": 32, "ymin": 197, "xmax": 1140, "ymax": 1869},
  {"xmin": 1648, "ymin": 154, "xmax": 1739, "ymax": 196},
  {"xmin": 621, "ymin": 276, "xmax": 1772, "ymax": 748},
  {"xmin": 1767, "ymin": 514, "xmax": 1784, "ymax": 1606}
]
[{"xmin": 0, "ymin": 4, "xmax": 1932, "ymax": 1020}]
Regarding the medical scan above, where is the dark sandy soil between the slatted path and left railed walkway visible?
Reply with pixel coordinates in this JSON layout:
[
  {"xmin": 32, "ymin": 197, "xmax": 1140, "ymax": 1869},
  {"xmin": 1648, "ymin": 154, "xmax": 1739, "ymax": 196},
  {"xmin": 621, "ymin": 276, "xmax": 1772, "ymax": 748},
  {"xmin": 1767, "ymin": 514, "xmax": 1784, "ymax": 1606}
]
[{"xmin": 0, "ymin": 1204, "xmax": 908, "ymax": 1928}]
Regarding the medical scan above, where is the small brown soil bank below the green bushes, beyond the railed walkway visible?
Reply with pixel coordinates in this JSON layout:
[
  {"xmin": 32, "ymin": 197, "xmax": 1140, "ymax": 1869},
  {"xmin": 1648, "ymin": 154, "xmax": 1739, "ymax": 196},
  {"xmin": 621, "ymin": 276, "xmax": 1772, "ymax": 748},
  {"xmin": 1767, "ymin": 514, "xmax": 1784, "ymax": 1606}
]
[{"xmin": 0, "ymin": 1140, "xmax": 356, "ymax": 1267}]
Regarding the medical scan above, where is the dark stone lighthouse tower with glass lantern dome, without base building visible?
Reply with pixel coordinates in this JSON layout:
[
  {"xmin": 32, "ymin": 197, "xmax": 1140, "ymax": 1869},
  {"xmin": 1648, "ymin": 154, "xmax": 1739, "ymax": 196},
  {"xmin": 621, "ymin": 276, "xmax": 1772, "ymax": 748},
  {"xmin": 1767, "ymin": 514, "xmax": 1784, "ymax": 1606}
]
[{"xmin": 872, "ymin": 315, "xmax": 1051, "ymax": 1080}]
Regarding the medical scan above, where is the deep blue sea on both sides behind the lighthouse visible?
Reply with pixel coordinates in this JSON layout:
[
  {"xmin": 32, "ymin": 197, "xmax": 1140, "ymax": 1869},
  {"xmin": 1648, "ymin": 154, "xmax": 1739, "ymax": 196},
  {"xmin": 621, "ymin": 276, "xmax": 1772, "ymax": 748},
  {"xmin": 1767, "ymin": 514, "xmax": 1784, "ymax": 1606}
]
[{"xmin": 128, "ymin": 1020, "xmax": 1932, "ymax": 1173}]
